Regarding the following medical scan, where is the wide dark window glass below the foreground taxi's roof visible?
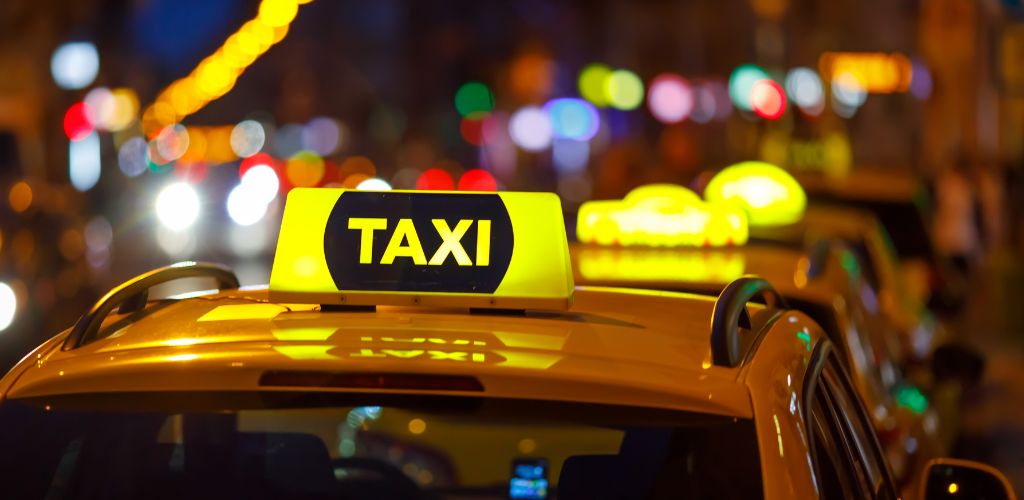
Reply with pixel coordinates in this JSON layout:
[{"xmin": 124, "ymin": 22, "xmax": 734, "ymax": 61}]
[{"xmin": 0, "ymin": 394, "xmax": 762, "ymax": 499}]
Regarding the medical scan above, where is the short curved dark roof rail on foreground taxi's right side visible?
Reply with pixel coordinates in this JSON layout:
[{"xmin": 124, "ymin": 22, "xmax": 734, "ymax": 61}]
[{"xmin": 711, "ymin": 276, "xmax": 788, "ymax": 367}]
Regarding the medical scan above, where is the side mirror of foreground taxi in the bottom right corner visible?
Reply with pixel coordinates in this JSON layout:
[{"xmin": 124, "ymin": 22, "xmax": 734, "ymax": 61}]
[{"xmin": 918, "ymin": 458, "xmax": 1017, "ymax": 500}]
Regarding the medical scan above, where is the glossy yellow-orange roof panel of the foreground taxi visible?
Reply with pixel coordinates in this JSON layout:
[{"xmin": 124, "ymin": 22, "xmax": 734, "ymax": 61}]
[{"xmin": 6, "ymin": 287, "xmax": 757, "ymax": 416}]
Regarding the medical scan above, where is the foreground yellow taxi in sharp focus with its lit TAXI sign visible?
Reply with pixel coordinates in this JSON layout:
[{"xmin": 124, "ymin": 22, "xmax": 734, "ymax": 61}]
[{"xmin": 0, "ymin": 189, "xmax": 1014, "ymax": 500}]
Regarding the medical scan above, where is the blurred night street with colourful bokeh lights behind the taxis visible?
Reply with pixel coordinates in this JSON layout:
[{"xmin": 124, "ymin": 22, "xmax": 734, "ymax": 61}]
[{"xmin": 0, "ymin": 0, "xmax": 1024, "ymax": 491}]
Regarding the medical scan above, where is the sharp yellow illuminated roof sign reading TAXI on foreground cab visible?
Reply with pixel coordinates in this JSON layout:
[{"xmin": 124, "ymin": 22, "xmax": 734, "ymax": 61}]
[{"xmin": 270, "ymin": 189, "xmax": 573, "ymax": 308}]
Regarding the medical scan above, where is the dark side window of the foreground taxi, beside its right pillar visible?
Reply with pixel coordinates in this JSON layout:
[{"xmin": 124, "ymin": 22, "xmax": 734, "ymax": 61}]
[{"xmin": 810, "ymin": 351, "xmax": 896, "ymax": 500}]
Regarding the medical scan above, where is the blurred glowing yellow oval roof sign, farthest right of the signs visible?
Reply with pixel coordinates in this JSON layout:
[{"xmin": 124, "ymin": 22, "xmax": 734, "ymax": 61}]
[{"xmin": 705, "ymin": 162, "xmax": 807, "ymax": 226}]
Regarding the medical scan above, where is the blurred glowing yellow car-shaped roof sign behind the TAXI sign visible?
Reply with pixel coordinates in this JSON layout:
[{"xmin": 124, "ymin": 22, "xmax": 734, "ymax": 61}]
[{"xmin": 577, "ymin": 184, "xmax": 748, "ymax": 247}]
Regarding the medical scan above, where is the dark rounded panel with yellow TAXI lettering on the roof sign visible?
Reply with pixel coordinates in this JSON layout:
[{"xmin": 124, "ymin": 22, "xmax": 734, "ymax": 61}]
[{"xmin": 324, "ymin": 191, "xmax": 514, "ymax": 293}]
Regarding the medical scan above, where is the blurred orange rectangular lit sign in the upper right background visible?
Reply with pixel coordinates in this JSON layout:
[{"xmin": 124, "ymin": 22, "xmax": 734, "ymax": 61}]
[{"xmin": 818, "ymin": 52, "xmax": 912, "ymax": 93}]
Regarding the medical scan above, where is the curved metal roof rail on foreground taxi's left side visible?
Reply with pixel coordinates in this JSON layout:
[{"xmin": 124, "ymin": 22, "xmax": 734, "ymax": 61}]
[{"xmin": 61, "ymin": 261, "xmax": 239, "ymax": 350}]
